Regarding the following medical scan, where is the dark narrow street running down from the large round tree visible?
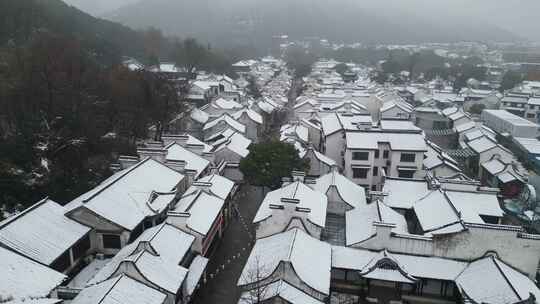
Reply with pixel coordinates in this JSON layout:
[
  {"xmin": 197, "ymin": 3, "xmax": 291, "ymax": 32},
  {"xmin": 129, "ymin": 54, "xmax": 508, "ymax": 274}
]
[{"xmin": 194, "ymin": 185, "xmax": 263, "ymax": 304}]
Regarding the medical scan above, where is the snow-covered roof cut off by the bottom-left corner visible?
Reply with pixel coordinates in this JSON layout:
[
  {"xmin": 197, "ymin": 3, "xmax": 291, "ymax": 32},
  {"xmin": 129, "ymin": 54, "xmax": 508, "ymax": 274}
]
[{"xmin": 0, "ymin": 246, "xmax": 67, "ymax": 300}]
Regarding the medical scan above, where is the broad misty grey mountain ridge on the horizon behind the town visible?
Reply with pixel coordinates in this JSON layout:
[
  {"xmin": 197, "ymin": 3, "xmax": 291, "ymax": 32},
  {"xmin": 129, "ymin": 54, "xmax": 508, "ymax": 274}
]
[{"xmin": 105, "ymin": 0, "xmax": 521, "ymax": 43}]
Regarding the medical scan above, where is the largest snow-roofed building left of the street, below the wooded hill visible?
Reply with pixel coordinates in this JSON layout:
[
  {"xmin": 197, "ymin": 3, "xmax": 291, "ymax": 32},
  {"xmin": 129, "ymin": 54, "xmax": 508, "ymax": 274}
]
[{"xmin": 66, "ymin": 158, "xmax": 185, "ymax": 254}]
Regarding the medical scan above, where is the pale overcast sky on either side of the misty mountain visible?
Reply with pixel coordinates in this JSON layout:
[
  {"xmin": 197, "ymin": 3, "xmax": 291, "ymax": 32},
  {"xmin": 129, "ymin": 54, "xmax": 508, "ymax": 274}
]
[{"xmin": 64, "ymin": 0, "xmax": 540, "ymax": 41}]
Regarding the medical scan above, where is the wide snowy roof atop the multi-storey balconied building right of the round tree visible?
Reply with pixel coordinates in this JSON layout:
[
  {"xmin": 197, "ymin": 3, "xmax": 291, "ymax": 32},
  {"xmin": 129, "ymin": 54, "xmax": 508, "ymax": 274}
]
[{"xmin": 346, "ymin": 132, "xmax": 427, "ymax": 152}]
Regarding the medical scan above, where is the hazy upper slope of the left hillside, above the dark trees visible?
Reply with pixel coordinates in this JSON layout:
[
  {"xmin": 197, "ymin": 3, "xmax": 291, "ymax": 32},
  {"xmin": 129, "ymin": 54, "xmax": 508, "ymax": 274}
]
[{"xmin": 0, "ymin": 0, "xmax": 150, "ymax": 63}]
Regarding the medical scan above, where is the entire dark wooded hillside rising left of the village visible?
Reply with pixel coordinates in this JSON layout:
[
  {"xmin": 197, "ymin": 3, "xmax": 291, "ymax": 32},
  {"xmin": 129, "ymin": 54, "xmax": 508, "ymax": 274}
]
[{"xmin": 0, "ymin": 0, "xmax": 179, "ymax": 217}]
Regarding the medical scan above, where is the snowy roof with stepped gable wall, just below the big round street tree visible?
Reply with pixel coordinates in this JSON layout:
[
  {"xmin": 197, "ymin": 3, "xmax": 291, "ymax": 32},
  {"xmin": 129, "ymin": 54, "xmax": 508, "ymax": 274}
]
[{"xmin": 253, "ymin": 181, "xmax": 328, "ymax": 227}]
